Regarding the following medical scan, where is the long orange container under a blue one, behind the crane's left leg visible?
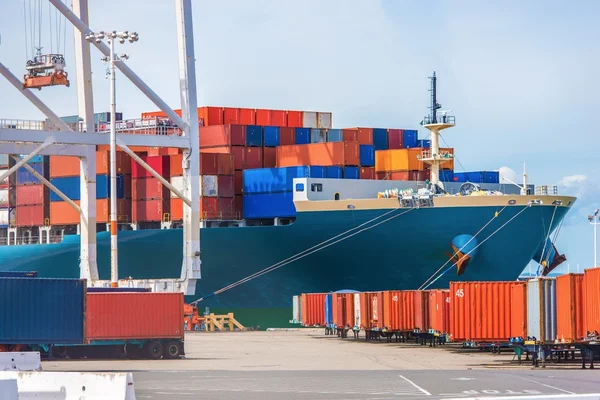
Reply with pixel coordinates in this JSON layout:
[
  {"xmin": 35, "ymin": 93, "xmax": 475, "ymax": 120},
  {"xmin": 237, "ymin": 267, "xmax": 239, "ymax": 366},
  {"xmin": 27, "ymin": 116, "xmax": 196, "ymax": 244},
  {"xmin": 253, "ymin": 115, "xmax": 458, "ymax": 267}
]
[{"xmin": 50, "ymin": 199, "xmax": 131, "ymax": 225}]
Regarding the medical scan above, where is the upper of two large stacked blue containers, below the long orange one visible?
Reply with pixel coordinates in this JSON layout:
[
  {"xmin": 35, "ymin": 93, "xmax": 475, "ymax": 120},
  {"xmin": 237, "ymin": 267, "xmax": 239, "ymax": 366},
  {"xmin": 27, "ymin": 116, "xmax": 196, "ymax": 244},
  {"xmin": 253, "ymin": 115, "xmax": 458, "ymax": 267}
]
[{"xmin": 243, "ymin": 166, "xmax": 325, "ymax": 194}]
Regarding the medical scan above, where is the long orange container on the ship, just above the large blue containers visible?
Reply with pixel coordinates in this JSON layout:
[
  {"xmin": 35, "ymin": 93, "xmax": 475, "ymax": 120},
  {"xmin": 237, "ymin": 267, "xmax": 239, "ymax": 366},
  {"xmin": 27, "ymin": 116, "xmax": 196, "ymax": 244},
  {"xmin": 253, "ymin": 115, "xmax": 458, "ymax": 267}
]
[{"xmin": 277, "ymin": 142, "xmax": 360, "ymax": 167}]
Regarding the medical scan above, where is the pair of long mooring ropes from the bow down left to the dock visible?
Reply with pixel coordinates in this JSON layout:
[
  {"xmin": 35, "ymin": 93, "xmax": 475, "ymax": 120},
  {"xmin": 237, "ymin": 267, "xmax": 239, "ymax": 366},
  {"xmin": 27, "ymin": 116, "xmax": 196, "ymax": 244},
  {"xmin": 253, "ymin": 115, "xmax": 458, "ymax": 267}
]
[{"xmin": 190, "ymin": 207, "xmax": 418, "ymax": 305}]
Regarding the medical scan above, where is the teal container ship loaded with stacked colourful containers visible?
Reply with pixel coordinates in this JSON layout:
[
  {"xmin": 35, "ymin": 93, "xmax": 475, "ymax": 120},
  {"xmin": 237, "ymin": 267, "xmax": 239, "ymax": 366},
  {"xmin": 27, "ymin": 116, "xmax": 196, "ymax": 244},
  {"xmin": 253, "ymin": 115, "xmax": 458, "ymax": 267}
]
[{"xmin": 0, "ymin": 77, "xmax": 576, "ymax": 328}]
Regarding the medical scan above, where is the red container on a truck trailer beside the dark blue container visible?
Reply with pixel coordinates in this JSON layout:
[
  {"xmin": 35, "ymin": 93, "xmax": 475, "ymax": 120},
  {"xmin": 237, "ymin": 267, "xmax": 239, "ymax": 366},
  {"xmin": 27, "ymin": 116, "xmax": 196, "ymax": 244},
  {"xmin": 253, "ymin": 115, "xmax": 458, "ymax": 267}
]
[{"xmin": 85, "ymin": 293, "xmax": 183, "ymax": 341}]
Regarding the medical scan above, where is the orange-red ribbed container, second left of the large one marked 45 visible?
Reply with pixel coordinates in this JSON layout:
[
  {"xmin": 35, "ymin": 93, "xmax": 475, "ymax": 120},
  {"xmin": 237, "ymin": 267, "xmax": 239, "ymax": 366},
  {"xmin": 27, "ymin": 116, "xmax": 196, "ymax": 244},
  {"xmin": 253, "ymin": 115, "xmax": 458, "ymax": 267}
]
[{"xmin": 382, "ymin": 290, "xmax": 415, "ymax": 332}]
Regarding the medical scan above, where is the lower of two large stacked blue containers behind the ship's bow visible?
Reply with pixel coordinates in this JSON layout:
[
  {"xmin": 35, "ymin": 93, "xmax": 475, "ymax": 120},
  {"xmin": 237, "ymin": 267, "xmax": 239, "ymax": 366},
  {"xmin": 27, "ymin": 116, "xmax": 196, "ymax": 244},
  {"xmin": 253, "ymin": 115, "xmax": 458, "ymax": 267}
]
[{"xmin": 244, "ymin": 192, "xmax": 296, "ymax": 219}]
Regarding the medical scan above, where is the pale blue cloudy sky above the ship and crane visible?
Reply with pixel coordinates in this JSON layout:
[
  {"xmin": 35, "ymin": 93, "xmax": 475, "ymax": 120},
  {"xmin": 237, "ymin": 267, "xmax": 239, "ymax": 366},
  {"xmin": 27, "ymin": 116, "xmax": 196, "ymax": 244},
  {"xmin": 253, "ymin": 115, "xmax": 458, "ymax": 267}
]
[{"xmin": 0, "ymin": 0, "xmax": 600, "ymax": 270}]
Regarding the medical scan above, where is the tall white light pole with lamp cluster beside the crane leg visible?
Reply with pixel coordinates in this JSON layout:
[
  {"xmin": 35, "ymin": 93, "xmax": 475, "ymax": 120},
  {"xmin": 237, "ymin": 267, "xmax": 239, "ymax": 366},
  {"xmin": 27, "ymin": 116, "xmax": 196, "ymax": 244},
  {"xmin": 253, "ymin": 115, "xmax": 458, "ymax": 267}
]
[{"xmin": 85, "ymin": 31, "xmax": 139, "ymax": 287}]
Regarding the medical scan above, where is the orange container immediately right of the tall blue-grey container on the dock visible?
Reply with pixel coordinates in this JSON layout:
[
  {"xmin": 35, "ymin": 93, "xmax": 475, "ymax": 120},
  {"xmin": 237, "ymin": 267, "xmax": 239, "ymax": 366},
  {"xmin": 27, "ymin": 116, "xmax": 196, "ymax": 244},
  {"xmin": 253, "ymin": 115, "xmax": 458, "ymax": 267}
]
[{"xmin": 556, "ymin": 274, "xmax": 585, "ymax": 342}]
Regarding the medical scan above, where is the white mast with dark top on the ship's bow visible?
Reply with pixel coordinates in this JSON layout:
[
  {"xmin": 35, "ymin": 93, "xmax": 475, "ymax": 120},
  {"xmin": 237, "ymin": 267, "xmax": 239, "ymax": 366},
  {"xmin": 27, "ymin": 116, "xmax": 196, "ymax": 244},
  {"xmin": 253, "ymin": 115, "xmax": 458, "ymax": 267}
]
[{"xmin": 420, "ymin": 71, "xmax": 455, "ymax": 189}]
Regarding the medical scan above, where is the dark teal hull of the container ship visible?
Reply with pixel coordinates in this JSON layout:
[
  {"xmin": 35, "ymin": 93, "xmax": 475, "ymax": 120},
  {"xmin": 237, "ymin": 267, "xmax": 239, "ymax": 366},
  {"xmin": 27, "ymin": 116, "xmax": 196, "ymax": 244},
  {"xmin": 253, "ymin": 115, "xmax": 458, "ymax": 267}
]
[{"xmin": 0, "ymin": 206, "xmax": 568, "ymax": 328}]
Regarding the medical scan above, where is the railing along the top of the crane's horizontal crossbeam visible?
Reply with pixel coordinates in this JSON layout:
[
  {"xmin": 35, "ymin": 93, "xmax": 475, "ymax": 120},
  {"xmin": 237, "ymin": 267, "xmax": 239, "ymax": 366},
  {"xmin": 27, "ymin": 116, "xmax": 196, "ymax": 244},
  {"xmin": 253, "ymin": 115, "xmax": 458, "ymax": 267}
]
[{"xmin": 0, "ymin": 117, "xmax": 181, "ymax": 136}]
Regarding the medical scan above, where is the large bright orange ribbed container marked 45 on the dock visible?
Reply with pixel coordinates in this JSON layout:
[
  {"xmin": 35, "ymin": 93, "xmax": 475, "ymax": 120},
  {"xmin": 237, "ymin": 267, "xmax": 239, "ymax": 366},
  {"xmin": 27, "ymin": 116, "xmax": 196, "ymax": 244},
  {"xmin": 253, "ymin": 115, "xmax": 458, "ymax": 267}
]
[{"xmin": 450, "ymin": 281, "xmax": 527, "ymax": 341}]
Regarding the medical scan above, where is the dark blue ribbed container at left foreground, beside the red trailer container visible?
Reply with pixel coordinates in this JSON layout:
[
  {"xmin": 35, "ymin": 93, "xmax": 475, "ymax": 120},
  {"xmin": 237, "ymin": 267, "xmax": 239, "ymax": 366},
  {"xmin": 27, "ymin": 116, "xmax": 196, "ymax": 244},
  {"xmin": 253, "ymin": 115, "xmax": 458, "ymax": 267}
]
[{"xmin": 0, "ymin": 278, "xmax": 86, "ymax": 344}]
